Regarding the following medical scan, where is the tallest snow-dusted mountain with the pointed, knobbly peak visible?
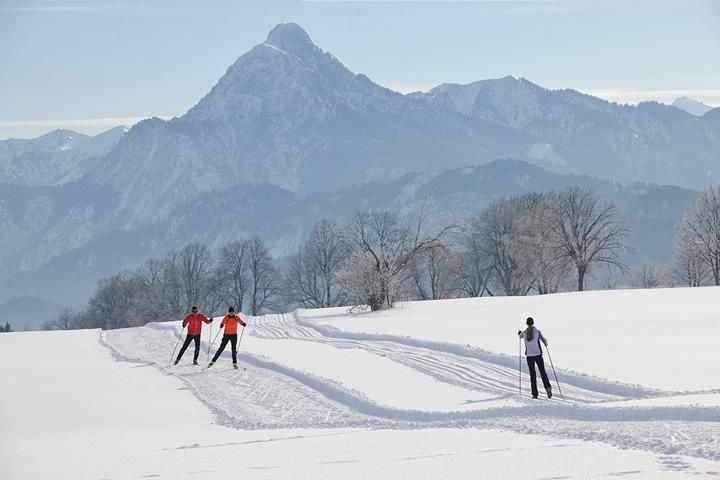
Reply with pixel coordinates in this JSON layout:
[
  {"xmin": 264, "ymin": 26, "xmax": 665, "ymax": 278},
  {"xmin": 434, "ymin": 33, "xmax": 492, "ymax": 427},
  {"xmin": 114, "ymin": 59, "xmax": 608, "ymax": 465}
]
[{"xmin": 84, "ymin": 24, "xmax": 522, "ymax": 219}]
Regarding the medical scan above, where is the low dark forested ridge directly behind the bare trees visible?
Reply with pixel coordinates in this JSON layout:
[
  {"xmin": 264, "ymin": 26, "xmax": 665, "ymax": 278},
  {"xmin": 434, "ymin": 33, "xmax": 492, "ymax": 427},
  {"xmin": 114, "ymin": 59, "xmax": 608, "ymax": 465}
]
[{"xmin": 0, "ymin": 159, "xmax": 697, "ymax": 303}]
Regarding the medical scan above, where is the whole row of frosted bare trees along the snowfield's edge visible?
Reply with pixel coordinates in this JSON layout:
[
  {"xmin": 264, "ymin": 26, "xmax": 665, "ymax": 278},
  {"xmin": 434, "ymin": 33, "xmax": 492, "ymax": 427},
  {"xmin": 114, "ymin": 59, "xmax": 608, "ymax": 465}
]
[{"xmin": 44, "ymin": 186, "xmax": 720, "ymax": 329}]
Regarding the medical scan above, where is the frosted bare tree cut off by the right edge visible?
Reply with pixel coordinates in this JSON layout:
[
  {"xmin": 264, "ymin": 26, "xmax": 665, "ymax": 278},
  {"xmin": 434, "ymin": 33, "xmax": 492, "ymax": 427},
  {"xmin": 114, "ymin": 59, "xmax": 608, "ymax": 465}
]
[{"xmin": 678, "ymin": 185, "xmax": 720, "ymax": 285}]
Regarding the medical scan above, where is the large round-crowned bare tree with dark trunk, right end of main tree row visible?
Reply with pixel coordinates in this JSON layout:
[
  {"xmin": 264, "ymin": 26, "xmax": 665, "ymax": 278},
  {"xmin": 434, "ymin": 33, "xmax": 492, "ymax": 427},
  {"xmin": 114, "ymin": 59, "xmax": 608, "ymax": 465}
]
[{"xmin": 551, "ymin": 187, "xmax": 630, "ymax": 291}]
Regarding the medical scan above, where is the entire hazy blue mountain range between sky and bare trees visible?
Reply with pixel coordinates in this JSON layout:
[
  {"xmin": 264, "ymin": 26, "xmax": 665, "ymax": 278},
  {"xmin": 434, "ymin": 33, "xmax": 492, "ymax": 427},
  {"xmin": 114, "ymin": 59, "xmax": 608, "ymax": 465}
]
[{"xmin": 0, "ymin": 24, "xmax": 720, "ymax": 320}]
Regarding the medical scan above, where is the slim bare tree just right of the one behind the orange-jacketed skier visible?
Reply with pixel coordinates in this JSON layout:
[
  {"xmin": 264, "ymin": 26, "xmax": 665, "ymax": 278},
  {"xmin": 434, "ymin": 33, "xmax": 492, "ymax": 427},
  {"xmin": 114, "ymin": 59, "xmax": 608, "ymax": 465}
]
[{"xmin": 248, "ymin": 237, "xmax": 279, "ymax": 316}]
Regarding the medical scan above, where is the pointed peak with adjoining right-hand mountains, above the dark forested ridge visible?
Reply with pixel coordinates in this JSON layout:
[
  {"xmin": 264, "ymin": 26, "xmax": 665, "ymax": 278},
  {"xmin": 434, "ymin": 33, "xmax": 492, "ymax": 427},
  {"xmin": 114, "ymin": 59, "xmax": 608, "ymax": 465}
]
[{"xmin": 80, "ymin": 24, "xmax": 720, "ymax": 223}]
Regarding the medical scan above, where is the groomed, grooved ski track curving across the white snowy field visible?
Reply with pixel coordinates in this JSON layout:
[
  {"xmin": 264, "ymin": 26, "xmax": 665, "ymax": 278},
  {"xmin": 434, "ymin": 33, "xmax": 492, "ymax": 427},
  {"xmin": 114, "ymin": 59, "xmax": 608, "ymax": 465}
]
[{"xmin": 100, "ymin": 312, "xmax": 720, "ymax": 461}]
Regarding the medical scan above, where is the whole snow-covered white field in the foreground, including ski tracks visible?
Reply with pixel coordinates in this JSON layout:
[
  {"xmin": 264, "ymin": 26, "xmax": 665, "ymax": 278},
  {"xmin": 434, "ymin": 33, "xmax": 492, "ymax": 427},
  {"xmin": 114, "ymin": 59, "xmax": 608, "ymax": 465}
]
[{"xmin": 0, "ymin": 287, "xmax": 720, "ymax": 480}]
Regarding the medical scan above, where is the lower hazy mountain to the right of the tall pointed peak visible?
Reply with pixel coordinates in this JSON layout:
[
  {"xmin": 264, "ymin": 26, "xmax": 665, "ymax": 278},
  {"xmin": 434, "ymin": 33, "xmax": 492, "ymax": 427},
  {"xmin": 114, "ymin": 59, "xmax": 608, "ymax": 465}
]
[{"xmin": 412, "ymin": 77, "xmax": 720, "ymax": 188}]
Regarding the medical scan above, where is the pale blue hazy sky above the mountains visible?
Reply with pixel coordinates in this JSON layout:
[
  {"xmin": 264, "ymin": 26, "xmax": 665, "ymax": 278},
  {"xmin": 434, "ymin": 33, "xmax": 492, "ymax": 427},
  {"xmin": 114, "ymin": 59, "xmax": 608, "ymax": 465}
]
[{"xmin": 0, "ymin": 0, "xmax": 720, "ymax": 139}]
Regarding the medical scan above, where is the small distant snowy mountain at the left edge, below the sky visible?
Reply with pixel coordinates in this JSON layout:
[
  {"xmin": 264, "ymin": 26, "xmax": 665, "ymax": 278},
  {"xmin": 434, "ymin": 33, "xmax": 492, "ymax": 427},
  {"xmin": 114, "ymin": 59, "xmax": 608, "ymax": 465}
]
[{"xmin": 0, "ymin": 127, "xmax": 127, "ymax": 186}]
